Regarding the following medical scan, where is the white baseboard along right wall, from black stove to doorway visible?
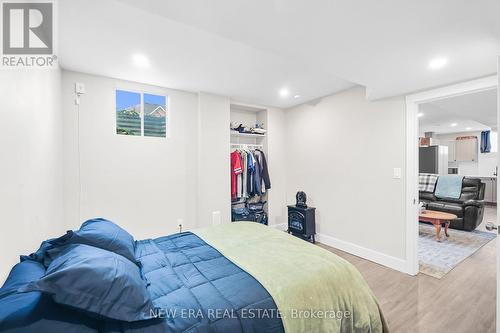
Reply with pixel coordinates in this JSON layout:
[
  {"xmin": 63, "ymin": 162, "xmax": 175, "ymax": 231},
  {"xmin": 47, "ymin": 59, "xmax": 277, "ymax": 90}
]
[{"xmin": 316, "ymin": 234, "xmax": 407, "ymax": 273}]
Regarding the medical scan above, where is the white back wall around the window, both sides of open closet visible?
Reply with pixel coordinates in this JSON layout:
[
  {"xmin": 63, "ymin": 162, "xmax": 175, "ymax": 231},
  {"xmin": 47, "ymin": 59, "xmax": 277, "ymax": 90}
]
[{"xmin": 63, "ymin": 71, "xmax": 285, "ymax": 232}]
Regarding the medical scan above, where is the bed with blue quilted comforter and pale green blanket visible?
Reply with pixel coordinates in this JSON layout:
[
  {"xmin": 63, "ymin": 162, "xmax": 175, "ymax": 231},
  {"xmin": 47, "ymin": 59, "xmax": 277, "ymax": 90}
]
[{"xmin": 0, "ymin": 222, "xmax": 388, "ymax": 333}]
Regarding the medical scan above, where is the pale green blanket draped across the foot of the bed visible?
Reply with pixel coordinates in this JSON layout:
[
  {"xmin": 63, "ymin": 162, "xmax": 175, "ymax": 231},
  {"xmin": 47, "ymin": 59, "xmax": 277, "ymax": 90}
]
[{"xmin": 193, "ymin": 222, "xmax": 388, "ymax": 333}]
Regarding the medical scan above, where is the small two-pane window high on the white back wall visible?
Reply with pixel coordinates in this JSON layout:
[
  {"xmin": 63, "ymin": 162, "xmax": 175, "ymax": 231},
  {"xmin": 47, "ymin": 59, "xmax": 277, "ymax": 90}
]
[{"xmin": 115, "ymin": 90, "xmax": 168, "ymax": 138}]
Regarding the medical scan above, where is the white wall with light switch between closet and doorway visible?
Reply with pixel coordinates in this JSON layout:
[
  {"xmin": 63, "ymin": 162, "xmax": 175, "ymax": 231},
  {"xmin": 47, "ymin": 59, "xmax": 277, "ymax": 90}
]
[{"xmin": 286, "ymin": 87, "xmax": 405, "ymax": 264}]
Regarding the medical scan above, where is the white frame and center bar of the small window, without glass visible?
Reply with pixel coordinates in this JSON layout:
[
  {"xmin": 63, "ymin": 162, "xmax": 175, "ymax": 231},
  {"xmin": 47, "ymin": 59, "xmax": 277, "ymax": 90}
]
[{"xmin": 113, "ymin": 85, "xmax": 172, "ymax": 139}]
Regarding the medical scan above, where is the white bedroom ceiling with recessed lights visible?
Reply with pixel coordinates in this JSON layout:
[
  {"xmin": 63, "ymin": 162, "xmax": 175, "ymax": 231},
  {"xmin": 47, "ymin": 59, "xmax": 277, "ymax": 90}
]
[{"xmin": 55, "ymin": 0, "xmax": 500, "ymax": 107}]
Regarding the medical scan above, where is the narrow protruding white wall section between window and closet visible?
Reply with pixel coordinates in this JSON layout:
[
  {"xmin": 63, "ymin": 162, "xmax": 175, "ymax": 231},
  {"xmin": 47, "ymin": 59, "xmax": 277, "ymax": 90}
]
[{"xmin": 197, "ymin": 93, "xmax": 231, "ymax": 227}]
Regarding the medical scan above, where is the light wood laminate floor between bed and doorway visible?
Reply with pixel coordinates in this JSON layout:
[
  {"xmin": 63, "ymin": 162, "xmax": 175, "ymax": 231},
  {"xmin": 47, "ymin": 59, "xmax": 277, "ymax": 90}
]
[{"xmin": 319, "ymin": 213, "xmax": 496, "ymax": 333}]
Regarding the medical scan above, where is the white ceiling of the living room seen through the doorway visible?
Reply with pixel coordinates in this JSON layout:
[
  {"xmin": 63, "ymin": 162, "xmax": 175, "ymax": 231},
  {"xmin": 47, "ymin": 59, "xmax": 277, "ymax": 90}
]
[{"xmin": 419, "ymin": 89, "xmax": 497, "ymax": 134}]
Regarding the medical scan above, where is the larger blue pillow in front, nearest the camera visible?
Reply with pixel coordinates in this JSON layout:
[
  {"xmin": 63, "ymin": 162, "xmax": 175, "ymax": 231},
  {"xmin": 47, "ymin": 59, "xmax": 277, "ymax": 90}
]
[{"xmin": 18, "ymin": 244, "xmax": 154, "ymax": 322}]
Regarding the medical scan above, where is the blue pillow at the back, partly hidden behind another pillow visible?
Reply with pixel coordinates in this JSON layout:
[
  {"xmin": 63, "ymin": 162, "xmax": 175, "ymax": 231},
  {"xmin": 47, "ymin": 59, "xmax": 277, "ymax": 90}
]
[{"xmin": 52, "ymin": 218, "xmax": 136, "ymax": 262}]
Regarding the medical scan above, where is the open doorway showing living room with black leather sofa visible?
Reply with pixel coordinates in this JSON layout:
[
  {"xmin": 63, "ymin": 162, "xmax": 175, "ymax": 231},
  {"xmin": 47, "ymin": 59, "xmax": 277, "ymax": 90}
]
[{"xmin": 417, "ymin": 88, "xmax": 498, "ymax": 279}]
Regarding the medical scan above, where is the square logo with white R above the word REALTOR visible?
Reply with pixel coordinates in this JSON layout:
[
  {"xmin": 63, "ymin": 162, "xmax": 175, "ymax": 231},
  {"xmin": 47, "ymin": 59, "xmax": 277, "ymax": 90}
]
[{"xmin": 2, "ymin": 2, "xmax": 53, "ymax": 54}]
